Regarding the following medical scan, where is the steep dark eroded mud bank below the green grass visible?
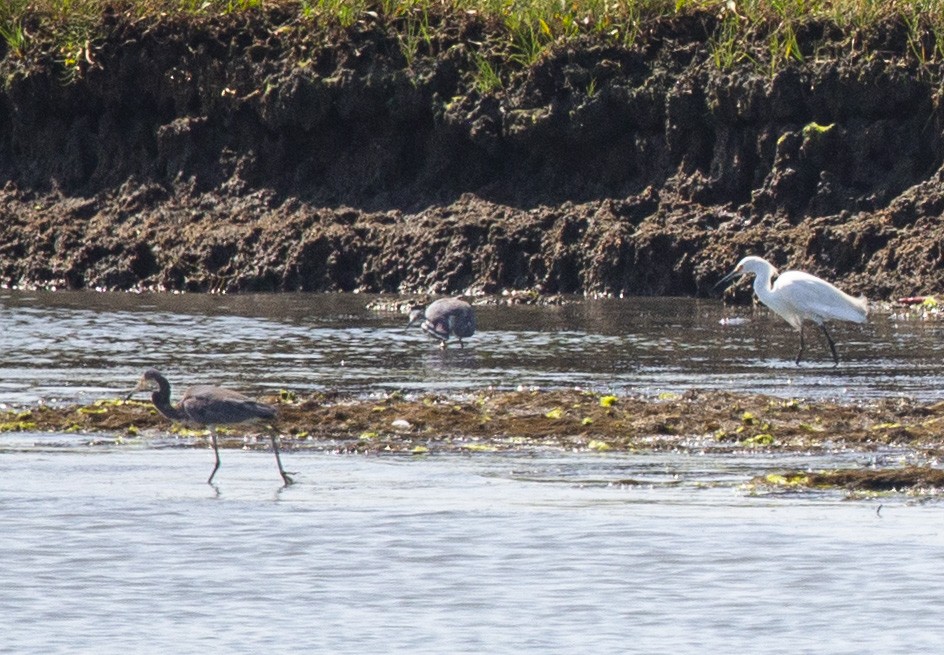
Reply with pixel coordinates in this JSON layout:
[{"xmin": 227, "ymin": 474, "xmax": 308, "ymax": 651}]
[{"xmin": 0, "ymin": 9, "xmax": 944, "ymax": 298}]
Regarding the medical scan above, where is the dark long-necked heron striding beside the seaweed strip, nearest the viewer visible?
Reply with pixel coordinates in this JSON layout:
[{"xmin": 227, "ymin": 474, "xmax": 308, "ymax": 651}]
[{"xmin": 127, "ymin": 368, "xmax": 293, "ymax": 485}]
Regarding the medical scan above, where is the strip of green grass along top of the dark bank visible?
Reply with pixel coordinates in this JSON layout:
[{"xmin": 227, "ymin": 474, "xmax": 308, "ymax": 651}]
[{"xmin": 0, "ymin": 0, "xmax": 944, "ymax": 81}]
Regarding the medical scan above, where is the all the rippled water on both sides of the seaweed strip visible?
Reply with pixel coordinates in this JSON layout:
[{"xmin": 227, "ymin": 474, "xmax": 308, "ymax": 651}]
[{"xmin": 0, "ymin": 292, "xmax": 944, "ymax": 654}]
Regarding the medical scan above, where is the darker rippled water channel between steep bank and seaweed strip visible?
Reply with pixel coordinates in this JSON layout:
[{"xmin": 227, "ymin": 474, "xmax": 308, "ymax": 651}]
[{"xmin": 0, "ymin": 291, "xmax": 944, "ymax": 403}]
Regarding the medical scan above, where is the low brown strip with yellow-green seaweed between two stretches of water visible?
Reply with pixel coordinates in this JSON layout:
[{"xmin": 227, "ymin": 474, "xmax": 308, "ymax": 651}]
[{"xmin": 7, "ymin": 391, "xmax": 944, "ymax": 491}]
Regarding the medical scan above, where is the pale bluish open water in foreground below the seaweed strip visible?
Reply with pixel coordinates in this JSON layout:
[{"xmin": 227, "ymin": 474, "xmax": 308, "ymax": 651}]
[{"xmin": 0, "ymin": 448, "xmax": 944, "ymax": 653}]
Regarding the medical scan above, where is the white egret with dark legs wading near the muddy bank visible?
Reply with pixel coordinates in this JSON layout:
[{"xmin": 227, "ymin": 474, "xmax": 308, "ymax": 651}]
[{"xmin": 719, "ymin": 256, "xmax": 869, "ymax": 364}]
